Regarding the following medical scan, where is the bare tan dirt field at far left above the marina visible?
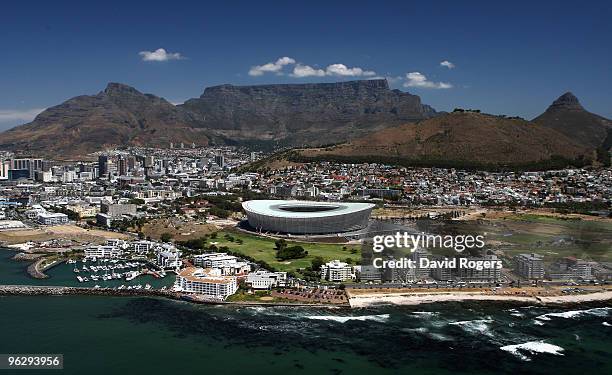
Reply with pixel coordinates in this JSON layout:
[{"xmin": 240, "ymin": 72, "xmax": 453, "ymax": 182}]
[{"xmin": 0, "ymin": 225, "xmax": 130, "ymax": 245}]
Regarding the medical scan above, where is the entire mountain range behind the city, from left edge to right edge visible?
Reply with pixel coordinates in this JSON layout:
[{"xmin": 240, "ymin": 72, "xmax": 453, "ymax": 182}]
[{"xmin": 0, "ymin": 80, "xmax": 612, "ymax": 169}]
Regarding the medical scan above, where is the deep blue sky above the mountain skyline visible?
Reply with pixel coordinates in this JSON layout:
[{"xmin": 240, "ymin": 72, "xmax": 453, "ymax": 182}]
[{"xmin": 0, "ymin": 1, "xmax": 612, "ymax": 129}]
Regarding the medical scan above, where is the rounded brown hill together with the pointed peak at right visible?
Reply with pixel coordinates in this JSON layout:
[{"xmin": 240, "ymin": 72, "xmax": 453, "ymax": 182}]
[{"xmin": 275, "ymin": 92, "xmax": 612, "ymax": 168}]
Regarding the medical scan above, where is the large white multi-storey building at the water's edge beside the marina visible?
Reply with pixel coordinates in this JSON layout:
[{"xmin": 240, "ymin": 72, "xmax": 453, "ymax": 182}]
[{"xmin": 174, "ymin": 267, "xmax": 238, "ymax": 300}]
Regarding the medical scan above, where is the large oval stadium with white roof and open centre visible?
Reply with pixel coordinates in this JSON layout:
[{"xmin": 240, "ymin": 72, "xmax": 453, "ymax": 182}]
[{"xmin": 242, "ymin": 200, "xmax": 374, "ymax": 234}]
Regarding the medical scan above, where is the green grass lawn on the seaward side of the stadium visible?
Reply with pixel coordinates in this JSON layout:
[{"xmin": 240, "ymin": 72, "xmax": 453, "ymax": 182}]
[{"xmin": 208, "ymin": 230, "xmax": 361, "ymax": 271}]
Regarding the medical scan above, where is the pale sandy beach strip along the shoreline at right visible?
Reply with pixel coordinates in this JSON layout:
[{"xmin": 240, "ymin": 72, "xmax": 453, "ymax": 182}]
[{"xmin": 349, "ymin": 290, "xmax": 612, "ymax": 308}]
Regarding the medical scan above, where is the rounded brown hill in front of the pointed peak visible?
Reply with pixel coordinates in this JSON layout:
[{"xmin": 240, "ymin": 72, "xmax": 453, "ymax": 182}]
[{"xmin": 276, "ymin": 112, "xmax": 592, "ymax": 167}]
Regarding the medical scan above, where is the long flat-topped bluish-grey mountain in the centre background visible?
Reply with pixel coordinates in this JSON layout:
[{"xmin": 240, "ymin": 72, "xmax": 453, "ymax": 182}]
[{"xmin": 181, "ymin": 79, "xmax": 436, "ymax": 145}]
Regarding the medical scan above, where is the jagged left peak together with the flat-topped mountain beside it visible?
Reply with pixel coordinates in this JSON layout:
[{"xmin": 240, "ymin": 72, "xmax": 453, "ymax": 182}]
[{"xmin": 0, "ymin": 80, "xmax": 436, "ymax": 158}]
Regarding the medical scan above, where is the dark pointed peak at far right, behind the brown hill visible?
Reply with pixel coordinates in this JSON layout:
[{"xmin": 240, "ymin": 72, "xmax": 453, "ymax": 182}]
[{"xmin": 533, "ymin": 92, "xmax": 612, "ymax": 149}]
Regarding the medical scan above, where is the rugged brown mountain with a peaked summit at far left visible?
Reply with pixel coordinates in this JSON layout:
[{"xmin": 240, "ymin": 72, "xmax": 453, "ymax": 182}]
[{"xmin": 0, "ymin": 83, "xmax": 209, "ymax": 158}]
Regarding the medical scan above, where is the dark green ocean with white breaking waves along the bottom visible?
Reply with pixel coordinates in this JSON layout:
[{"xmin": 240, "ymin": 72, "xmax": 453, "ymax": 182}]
[{"xmin": 0, "ymin": 248, "xmax": 612, "ymax": 374}]
